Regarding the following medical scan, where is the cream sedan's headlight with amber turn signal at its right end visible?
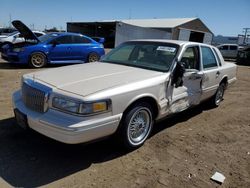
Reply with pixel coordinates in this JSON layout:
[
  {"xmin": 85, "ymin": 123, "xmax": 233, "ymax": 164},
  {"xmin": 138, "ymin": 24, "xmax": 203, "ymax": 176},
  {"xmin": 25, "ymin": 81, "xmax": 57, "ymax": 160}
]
[{"xmin": 52, "ymin": 97, "xmax": 111, "ymax": 115}]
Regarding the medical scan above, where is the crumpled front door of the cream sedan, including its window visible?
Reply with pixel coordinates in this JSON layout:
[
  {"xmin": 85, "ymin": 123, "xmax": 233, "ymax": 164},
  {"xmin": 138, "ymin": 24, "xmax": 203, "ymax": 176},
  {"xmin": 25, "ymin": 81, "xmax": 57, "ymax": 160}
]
[{"xmin": 169, "ymin": 46, "xmax": 203, "ymax": 113}]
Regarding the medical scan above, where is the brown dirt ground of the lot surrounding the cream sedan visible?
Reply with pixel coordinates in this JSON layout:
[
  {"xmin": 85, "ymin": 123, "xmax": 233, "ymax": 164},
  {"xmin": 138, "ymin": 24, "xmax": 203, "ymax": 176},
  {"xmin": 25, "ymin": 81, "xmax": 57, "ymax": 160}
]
[{"xmin": 0, "ymin": 60, "xmax": 250, "ymax": 188}]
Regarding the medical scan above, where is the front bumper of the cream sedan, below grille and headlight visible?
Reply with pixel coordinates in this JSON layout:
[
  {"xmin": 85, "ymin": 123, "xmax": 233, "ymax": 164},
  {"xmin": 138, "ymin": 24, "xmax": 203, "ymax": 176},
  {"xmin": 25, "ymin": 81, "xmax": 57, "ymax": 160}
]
[{"xmin": 12, "ymin": 91, "xmax": 122, "ymax": 144}]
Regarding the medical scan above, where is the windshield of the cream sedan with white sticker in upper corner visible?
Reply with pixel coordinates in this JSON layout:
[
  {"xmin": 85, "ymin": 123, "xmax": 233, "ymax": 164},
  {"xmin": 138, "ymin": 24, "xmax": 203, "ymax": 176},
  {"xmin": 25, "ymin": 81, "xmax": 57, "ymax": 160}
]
[{"xmin": 101, "ymin": 41, "xmax": 179, "ymax": 72}]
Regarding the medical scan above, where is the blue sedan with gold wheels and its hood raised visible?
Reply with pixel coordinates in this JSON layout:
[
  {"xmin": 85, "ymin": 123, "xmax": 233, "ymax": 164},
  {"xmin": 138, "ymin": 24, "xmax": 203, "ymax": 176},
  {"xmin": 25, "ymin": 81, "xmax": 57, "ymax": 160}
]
[{"xmin": 2, "ymin": 20, "xmax": 105, "ymax": 68}]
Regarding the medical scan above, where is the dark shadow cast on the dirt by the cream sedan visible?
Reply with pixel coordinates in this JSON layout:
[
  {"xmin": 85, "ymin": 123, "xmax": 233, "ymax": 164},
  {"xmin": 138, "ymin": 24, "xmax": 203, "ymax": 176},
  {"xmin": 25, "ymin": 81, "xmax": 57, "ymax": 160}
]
[{"xmin": 0, "ymin": 103, "xmax": 213, "ymax": 187}]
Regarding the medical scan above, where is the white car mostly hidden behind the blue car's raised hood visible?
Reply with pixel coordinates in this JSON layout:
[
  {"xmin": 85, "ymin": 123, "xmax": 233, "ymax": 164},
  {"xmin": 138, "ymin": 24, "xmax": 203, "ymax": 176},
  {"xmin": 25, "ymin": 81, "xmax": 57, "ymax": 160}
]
[{"xmin": 0, "ymin": 31, "xmax": 45, "ymax": 47}]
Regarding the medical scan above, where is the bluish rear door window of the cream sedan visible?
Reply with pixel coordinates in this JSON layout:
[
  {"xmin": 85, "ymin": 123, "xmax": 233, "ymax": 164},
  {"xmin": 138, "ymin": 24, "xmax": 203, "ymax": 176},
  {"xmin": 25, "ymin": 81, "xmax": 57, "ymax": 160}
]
[{"xmin": 201, "ymin": 46, "xmax": 218, "ymax": 69}]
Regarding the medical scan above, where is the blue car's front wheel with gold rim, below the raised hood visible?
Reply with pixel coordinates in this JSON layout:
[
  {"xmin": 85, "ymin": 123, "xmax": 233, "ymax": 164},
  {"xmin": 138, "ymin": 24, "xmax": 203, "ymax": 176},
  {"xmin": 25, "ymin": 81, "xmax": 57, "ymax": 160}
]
[{"xmin": 29, "ymin": 52, "xmax": 47, "ymax": 68}]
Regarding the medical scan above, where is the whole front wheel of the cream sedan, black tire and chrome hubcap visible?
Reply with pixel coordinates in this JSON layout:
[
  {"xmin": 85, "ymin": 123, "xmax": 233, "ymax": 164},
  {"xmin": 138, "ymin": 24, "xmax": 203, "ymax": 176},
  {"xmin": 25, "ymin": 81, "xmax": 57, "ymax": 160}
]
[{"xmin": 118, "ymin": 102, "xmax": 154, "ymax": 150}]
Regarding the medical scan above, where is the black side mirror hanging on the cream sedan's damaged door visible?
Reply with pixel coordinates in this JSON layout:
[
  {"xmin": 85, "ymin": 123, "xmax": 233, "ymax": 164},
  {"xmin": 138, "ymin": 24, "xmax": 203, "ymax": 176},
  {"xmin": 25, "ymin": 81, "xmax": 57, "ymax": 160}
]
[{"xmin": 171, "ymin": 62, "xmax": 185, "ymax": 88}]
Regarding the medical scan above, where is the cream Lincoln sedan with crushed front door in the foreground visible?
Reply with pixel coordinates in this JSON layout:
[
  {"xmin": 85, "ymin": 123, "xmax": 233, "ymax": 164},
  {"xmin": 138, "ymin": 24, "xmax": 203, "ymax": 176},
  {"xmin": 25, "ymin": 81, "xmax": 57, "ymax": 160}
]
[{"xmin": 13, "ymin": 40, "xmax": 236, "ymax": 149}]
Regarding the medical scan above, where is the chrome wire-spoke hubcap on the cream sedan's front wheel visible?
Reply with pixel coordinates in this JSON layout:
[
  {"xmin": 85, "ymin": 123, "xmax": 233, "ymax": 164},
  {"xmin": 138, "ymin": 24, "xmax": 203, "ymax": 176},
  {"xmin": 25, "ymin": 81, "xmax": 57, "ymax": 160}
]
[{"xmin": 128, "ymin": 108, "xmax": 152, "ymax": 144}]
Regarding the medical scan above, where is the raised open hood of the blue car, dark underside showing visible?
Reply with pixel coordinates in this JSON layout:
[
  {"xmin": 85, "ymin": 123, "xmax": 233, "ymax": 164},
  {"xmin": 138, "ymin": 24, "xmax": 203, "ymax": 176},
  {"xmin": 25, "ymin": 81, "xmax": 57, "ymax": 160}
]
[{"xmin": 12, "ymin": 20, "xmax": 39, "ymax": 43}]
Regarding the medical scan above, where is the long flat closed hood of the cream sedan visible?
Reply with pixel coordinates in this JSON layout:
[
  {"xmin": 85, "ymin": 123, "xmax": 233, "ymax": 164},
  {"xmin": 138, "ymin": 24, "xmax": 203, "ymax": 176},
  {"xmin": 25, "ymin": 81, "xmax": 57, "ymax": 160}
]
[{"xmin": 26, "ymin": 62, "xmax": 163, "ymax": 96}]
